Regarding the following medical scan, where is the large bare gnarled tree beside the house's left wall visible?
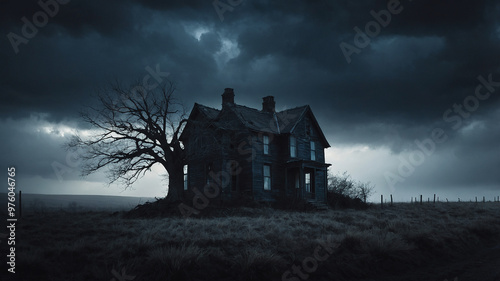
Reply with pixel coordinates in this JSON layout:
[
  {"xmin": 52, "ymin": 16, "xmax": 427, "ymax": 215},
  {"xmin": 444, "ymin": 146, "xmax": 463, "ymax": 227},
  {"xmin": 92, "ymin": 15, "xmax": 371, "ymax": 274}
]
[{"xmin": 67, "ymin": 81, "xmax": 187, "ymax": 201}]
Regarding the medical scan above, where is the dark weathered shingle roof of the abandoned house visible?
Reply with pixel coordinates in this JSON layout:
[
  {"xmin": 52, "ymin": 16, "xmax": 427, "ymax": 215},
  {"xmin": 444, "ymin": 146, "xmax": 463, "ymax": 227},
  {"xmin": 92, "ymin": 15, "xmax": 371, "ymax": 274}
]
[{"xmin": 182, "ymin": 103, "xmax": 330, "ymax": 147}]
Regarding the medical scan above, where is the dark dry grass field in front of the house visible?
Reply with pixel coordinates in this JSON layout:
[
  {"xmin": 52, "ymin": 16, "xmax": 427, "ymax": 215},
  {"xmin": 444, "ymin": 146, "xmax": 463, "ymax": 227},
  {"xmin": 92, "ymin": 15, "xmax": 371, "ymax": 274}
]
[{"xmin": 0, "ymin": 202, "xmax": 500, "ymax": 281}]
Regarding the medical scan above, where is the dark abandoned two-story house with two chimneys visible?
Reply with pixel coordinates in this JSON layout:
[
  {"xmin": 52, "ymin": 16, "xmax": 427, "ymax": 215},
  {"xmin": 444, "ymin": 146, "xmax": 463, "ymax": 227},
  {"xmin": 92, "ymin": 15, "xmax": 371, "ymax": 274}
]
[{"xmin": 180, "ymin": 88, "xmax": 330, "ymax": 202}]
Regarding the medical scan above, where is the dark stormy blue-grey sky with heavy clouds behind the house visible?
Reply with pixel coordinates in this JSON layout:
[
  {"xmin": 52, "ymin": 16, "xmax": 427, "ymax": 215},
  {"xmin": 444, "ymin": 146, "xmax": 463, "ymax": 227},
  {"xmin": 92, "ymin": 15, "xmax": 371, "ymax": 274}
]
[{"xmin": 0, "ymin": 0, "xmax": 500, "ymax": 200}]
